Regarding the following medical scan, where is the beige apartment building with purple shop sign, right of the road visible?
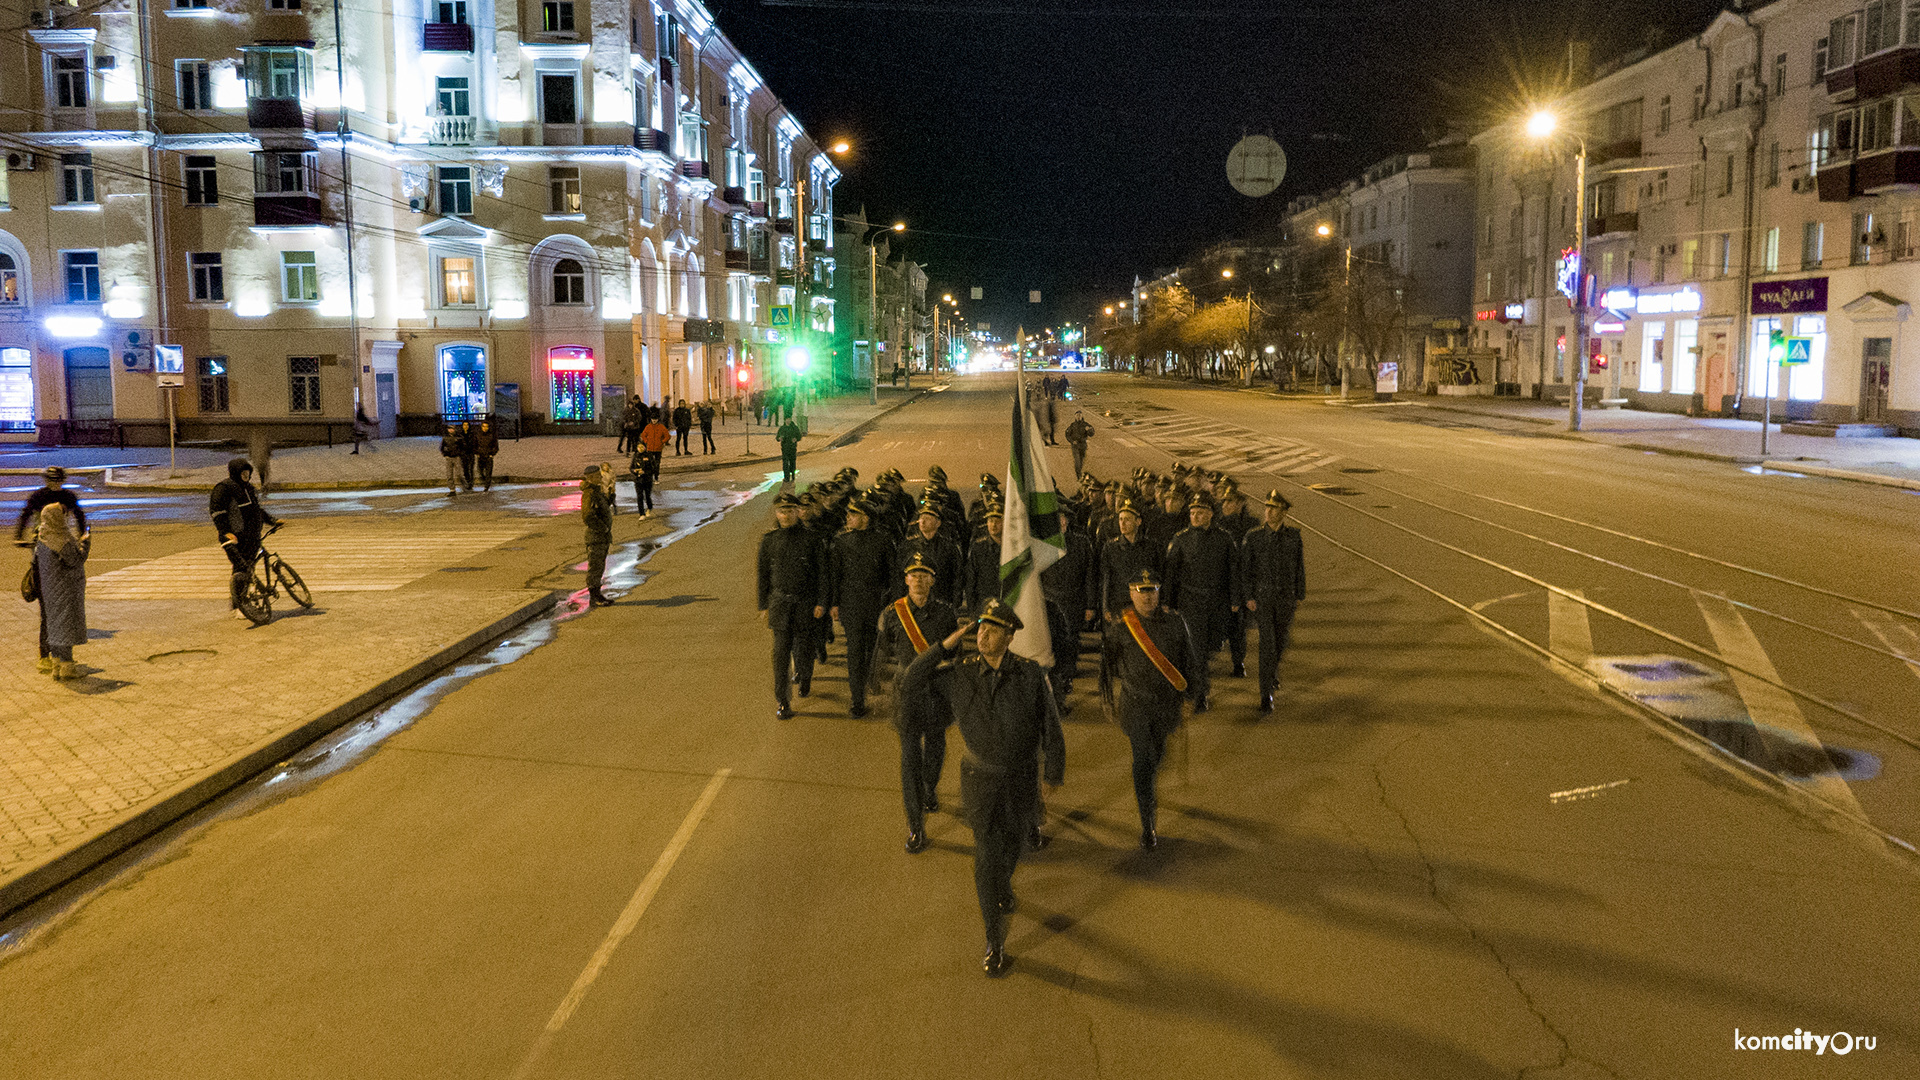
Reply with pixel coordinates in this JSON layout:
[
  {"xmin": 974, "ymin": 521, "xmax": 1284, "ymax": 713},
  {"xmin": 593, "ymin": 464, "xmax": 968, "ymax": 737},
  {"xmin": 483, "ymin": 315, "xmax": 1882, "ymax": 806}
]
[{"xmin": 1475, "ymin": 0, "xmax": 1920, "ymax": 430}]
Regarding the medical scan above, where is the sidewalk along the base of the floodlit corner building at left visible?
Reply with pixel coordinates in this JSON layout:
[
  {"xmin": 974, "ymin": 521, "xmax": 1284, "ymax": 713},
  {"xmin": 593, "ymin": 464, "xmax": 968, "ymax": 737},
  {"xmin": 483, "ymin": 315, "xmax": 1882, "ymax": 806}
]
[{"xmin": 93, "ymin": 386, "xmax": 929, "ymax": 492}]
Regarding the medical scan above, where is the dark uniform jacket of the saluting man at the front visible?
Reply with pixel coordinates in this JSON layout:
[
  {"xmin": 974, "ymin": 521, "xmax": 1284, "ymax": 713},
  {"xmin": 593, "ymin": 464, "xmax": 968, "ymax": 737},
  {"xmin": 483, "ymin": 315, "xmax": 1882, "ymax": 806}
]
[{"xmin": 900, "ymin": 642, "xmax": 1068, "ymax": 832}]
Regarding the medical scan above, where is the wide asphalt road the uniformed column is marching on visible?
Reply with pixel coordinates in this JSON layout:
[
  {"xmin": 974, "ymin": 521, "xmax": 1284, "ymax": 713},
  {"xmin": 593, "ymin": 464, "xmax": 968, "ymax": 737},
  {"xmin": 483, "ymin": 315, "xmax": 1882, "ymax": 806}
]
[{"xmin": 0, "ymin": 377, "xmax": 1920, "ymax": 1080}]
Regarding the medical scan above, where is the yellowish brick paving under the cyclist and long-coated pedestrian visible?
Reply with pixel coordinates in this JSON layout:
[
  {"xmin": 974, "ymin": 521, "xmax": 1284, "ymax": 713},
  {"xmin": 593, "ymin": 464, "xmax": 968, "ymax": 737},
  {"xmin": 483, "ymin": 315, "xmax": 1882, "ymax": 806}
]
[{"xmin": 0, "ymin": 588, "xmax": 545, "ymax": 882}]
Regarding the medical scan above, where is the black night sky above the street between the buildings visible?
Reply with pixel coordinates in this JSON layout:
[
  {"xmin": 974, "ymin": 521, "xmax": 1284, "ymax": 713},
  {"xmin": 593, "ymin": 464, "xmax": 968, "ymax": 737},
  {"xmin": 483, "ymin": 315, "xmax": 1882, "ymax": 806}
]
[{"xmin": 710, "ymin": 0, "xmax": 1732, "ymax": 332}]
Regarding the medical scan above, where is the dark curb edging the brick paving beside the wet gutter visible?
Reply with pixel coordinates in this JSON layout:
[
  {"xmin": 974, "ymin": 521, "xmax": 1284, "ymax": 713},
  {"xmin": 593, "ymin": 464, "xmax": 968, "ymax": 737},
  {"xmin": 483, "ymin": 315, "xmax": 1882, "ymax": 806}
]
[{"xmin": 0, "ymin": 590, "xmax": 563, "ymax": 917}]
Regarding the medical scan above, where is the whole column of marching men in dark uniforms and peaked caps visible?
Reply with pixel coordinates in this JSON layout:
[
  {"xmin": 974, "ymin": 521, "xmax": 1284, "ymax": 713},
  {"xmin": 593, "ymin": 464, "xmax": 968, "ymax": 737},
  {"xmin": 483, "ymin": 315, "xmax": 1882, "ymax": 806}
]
[{"xmin": 758, "ymin": 449, "xmax": 1306, "ymax": 976}]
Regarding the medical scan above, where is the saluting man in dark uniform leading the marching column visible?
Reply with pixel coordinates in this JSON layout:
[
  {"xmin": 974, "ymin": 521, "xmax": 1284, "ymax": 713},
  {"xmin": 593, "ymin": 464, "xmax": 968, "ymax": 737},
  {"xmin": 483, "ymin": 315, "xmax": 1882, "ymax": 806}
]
[{"xmin": 902, "ymin": 600, "xmax": 1066, "ymax": 976}]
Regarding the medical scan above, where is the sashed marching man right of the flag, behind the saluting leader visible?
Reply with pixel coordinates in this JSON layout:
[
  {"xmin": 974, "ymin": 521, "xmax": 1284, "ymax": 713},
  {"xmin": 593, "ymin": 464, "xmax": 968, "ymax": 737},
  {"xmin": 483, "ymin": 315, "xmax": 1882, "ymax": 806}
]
[{"xmin": 1100, "ymin": 571, "xmax": 1208, "ymax": 851}]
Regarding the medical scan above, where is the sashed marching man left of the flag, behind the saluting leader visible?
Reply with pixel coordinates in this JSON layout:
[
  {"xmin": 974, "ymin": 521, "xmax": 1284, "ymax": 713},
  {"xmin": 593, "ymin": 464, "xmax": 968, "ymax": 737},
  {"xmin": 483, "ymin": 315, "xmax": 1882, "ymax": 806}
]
[{"xmin": 874, "ymin": 559, "xmax": 960, "ymax": 855}]
